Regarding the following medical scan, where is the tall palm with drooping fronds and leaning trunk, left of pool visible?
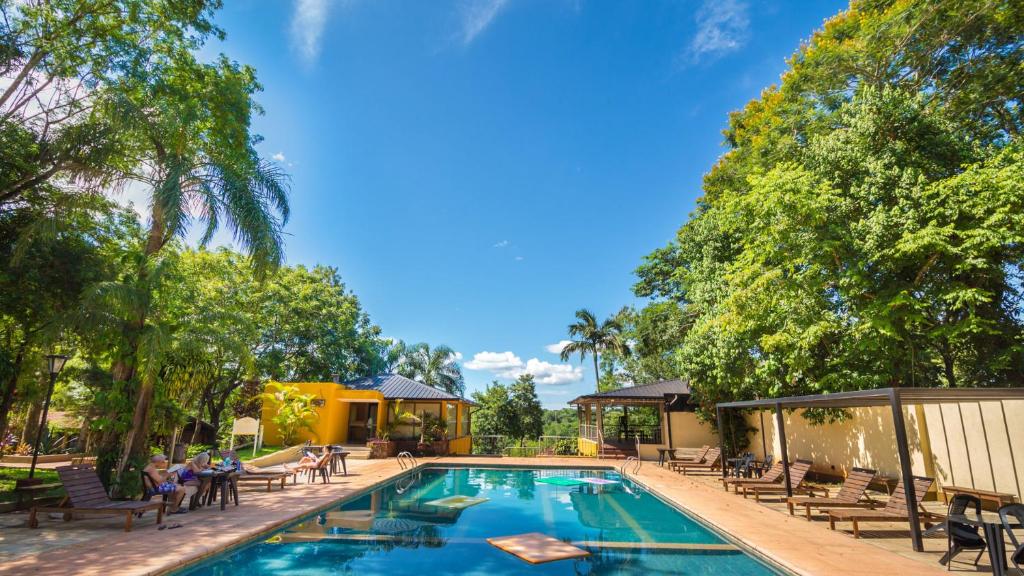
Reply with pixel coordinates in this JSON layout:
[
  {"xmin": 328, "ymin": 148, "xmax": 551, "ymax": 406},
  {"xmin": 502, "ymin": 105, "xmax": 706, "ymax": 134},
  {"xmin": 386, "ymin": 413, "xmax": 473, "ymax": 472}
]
[{"xmin": 112, "ymin": 57, "xmax": 289, "ymax": 476}]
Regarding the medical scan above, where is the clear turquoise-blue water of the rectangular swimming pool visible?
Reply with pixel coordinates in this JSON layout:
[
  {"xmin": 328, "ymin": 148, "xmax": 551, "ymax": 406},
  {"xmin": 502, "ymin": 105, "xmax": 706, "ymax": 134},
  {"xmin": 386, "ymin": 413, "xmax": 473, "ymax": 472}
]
[{"xmin": 180, "ymin": 468, "xmax": 778, "ymax": 576}]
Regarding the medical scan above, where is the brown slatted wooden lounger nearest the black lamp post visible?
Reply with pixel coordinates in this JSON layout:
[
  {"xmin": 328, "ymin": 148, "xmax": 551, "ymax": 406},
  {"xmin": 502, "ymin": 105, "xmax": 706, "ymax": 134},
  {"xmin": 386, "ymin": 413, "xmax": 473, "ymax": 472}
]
[{"xmin": 29, "ymin": 465, "xmax": 164, "ymax": 532}]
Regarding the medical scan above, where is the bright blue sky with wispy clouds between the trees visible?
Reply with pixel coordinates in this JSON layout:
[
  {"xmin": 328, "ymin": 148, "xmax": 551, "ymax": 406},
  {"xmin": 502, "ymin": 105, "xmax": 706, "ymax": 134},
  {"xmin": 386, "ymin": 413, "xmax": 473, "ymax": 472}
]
[{"xmin": 195, "ymin": 0, "xmax": 845, "ymax": 407}]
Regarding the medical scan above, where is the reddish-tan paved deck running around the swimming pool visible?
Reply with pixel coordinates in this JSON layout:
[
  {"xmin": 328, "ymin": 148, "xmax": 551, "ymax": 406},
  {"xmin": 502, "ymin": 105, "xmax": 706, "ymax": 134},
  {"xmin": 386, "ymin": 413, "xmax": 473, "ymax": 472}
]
[{"xmin": 0, "ymin": 457, "xmax": 974, "ymax": 576}]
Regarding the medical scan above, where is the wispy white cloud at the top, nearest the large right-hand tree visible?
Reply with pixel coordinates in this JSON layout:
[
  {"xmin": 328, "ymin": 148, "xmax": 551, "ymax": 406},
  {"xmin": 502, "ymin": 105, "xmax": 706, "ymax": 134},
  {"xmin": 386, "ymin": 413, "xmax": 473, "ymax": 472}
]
[{"xmin": 686, "ymin": 0, "xmax": 751, "ymax": 65}]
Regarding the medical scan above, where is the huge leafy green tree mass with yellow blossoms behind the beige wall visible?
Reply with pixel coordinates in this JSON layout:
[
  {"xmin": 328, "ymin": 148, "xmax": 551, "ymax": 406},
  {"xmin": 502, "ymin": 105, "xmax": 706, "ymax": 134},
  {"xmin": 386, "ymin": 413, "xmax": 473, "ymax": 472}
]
[{"xmin": 631, "ymin": 0, "xmax": 1024, "ymax": 424}]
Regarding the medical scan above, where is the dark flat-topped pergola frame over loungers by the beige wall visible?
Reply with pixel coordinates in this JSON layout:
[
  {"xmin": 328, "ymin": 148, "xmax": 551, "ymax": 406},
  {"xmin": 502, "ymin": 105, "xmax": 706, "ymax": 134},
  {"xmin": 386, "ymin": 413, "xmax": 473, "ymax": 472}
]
[{"xmin": 715, "ymin": 388, "xmax": 1024, "ymax": 552}]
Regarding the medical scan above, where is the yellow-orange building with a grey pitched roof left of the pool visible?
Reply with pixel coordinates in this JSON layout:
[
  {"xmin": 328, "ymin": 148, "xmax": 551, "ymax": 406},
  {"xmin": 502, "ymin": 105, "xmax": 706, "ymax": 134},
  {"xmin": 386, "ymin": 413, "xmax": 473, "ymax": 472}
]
[{"xmin": 262, "ymin": 374, "xmax": 473, "ymax": 454}]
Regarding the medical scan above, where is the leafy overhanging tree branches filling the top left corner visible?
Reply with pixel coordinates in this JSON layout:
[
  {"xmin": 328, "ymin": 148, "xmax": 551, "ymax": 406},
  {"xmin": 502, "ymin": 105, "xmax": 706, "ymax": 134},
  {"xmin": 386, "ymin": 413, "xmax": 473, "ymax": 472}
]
[{"xmin": 0, "ymin": 0, "xmax": 222, "ymax": 205}]
